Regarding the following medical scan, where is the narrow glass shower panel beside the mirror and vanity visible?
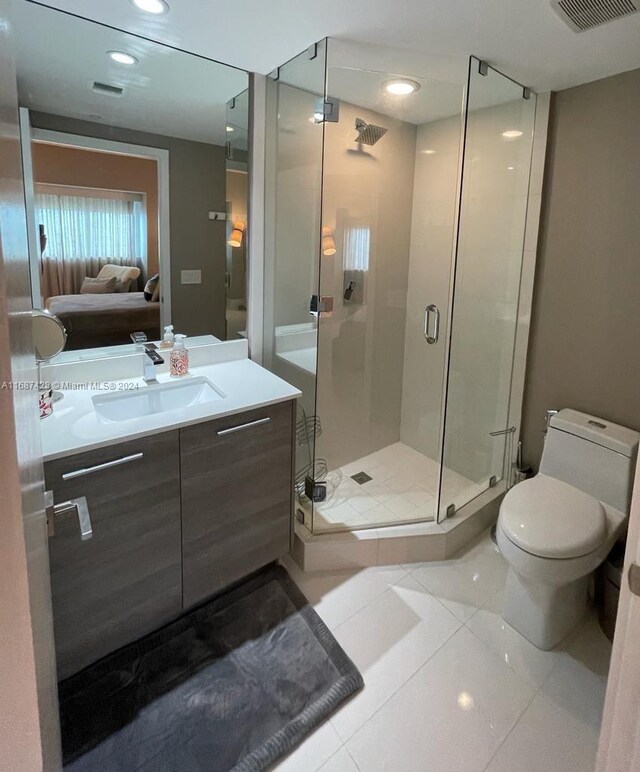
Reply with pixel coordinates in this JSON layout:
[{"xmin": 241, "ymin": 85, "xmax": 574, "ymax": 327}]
[{"xmin": 263, "ymin": 41, "xmax": 326, "ymax": 529}]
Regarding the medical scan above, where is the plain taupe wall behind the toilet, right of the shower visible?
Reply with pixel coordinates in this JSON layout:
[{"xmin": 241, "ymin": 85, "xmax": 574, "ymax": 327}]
[{"xmin": 523, "ymin": 70, "xmax": 640, "ymax": 467}]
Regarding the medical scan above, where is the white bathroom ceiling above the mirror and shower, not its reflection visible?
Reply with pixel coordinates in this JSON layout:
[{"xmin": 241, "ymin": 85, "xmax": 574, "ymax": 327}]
[{"xmin": 27, "ymin": 0, "xmax": 640, "ymax": 91}]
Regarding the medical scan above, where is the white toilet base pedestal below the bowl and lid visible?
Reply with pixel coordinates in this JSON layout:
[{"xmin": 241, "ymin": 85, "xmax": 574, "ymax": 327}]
[{"xmin": 502, "ymin": 567, "xmax": 590, "ymax": 651}]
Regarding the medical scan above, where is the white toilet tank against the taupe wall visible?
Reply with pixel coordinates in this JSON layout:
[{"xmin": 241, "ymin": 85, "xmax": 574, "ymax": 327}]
[{"xmin": 540, "ymin": 409, "xmax": 640, "ymax": 512}]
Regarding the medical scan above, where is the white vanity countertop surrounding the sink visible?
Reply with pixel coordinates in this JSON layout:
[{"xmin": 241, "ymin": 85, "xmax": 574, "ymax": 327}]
[{"xmin": 40, "ymin": 358, "xmax": 301, "ymax": 461}]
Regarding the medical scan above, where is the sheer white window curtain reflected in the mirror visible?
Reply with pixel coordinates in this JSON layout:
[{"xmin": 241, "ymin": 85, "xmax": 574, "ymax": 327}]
[{"xmin": 36, "ymin": 193, "xmax": 147, "ymax": 298}]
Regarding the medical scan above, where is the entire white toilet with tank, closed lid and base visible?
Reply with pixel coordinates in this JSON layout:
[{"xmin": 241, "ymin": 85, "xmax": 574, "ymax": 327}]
[{"xmin": 497, "ymin": 410, "xmax": 640, "ymax": 650}]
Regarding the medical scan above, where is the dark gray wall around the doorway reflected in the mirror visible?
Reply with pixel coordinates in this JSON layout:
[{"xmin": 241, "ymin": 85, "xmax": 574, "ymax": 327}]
[{"xmin": 31, "ymin": 112, "xmax": 226, "ymax": 340}]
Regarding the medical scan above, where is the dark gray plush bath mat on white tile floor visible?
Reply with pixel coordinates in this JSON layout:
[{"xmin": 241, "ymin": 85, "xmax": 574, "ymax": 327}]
[{"xmin": 59, "ymin": 566, "xmax": 363, "ymax": 772}]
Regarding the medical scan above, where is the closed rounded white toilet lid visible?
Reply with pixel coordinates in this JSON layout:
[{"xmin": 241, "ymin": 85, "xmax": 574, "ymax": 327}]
[{"xmin": 500, "ymin": 474, "xmax": 607, "ymax": 558}]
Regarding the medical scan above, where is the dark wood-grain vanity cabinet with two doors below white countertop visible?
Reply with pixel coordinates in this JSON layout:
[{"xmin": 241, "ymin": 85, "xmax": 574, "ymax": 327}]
[{"xmin": 45, "ymin": 402, "xmax": 295, "ymax": 679}]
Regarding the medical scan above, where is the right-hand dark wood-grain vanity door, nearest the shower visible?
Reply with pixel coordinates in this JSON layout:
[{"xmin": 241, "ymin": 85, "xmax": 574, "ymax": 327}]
[{"xmin": 180, "ymin": 402, "xmax": 293, "ymax": 608}]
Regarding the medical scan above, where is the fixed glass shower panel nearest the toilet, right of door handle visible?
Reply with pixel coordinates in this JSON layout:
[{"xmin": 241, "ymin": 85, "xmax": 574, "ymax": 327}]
[{"xmin": 439, "ymin": 57, "xmax": 536, "ymax": 520}]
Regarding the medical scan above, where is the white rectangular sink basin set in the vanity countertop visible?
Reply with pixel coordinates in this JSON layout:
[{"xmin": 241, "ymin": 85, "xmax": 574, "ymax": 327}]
[{"xmin": 92, "ymin": 378, "xmax": 225, "ymax": 422}]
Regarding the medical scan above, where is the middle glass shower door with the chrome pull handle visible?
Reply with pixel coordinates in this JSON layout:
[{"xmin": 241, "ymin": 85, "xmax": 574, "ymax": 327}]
[{"xmin": 313, "ymin": 40, "xmax": 464, "ymax": 533}]
